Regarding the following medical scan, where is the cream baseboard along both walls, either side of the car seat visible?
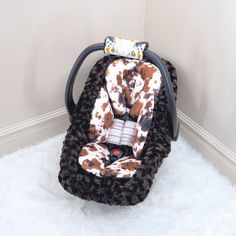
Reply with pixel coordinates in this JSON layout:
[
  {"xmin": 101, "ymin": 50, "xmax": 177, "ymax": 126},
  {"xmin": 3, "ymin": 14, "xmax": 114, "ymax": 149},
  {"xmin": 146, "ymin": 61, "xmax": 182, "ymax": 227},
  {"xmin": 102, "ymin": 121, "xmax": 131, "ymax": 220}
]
[{"xmin": 0, "ymin": 107, "xmax": 236, "ymax": 183}]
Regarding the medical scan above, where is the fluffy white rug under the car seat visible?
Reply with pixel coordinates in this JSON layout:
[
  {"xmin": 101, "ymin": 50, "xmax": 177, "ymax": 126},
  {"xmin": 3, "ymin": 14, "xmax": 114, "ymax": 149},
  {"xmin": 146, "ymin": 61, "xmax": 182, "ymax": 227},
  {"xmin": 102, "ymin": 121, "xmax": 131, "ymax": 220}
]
[{"xmin": 0, "ymin": 135, "xmax": 236, "ymax": 236}]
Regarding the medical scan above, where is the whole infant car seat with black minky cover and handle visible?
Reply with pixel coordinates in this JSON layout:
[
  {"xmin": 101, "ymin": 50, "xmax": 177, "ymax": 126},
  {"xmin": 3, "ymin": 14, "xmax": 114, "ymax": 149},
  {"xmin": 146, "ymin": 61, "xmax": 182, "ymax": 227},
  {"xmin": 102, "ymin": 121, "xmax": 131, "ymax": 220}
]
[{"xmin": 59, "ymin": 36, "xmax": 179, "ymax": 205}]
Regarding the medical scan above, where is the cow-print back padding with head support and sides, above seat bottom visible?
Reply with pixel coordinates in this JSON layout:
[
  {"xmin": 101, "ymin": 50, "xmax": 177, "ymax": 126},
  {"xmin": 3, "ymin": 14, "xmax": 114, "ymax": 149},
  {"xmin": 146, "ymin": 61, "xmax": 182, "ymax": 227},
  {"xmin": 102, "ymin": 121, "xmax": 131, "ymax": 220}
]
[{"xmin": 89, "ymin": 58, "xmax": 161, "ymax": 158}]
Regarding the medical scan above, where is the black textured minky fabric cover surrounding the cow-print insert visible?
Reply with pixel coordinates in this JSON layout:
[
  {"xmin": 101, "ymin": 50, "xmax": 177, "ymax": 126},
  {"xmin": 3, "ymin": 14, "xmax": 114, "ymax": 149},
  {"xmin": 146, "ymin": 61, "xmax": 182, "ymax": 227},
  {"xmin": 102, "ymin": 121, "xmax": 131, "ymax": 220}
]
[{"xmin": 59, "ymin": 56, "xmax": 177, "ymax": 206}]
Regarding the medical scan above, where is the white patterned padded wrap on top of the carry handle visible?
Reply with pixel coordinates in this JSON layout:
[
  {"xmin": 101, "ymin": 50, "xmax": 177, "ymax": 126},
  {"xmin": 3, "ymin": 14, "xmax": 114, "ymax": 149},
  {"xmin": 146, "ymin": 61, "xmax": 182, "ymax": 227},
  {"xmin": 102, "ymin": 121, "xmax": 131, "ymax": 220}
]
[{"xmin": 104, "ymin": 36, "xmax": 148, "ymax": 60}]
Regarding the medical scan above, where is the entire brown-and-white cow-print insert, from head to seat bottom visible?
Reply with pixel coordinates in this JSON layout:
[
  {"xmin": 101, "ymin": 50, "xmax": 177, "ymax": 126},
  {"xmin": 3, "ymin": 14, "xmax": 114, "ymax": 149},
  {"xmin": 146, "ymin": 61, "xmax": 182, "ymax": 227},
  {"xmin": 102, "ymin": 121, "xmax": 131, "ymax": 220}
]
[{"xmin": 78, "ymin": 58, "xmax": 161, "ymax": 178}]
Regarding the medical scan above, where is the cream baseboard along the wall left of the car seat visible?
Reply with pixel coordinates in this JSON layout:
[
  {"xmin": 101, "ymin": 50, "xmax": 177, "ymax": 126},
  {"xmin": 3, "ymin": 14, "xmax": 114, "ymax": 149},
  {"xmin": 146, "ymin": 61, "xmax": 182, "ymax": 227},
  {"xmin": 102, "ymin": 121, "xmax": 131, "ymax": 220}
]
[{"xmin": 0, "ymin": 107, "xmax": 69, "ymax": 156}]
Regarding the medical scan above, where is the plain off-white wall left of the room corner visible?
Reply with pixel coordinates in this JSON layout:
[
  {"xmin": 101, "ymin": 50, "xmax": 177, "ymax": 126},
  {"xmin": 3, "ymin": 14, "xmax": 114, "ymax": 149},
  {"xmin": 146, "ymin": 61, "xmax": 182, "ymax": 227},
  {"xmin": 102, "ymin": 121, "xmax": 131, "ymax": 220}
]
[{"xmin": 0, "ymin": 0, "xmax": 145, "ymax": 129}]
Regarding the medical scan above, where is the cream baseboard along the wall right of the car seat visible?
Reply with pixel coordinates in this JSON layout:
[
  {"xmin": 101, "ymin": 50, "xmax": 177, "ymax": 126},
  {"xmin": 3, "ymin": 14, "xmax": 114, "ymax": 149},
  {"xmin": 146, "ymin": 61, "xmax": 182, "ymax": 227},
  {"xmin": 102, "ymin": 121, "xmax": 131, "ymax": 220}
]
[{"xmin": 177, "ymin": 110, "xmax": 236, "ymax": 184}]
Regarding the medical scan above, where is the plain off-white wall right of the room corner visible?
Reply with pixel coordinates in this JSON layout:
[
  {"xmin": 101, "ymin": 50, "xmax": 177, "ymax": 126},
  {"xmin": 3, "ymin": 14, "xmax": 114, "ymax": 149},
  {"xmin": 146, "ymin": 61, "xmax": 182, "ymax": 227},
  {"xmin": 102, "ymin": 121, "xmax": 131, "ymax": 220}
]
[{"xmin": 145, "ymin": 0, "xmax": 236, "ymax": 152}]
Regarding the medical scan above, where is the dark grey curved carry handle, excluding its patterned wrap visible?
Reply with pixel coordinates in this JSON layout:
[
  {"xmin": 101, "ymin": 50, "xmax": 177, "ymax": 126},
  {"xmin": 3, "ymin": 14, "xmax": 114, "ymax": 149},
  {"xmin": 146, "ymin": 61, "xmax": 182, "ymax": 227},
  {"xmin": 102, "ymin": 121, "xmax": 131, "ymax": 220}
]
[{"xmin": 65, "ymin": 43, "xmax": 179, "ymax": 141}]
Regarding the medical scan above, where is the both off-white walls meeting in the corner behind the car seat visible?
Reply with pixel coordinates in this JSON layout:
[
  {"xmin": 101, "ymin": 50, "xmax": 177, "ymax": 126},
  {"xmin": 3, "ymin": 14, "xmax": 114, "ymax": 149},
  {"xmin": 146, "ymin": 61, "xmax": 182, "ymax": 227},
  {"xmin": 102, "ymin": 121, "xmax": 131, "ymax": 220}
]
[{"xmin": 0, "ymin": 0, "xmax": 236, "ymax": 161}]
